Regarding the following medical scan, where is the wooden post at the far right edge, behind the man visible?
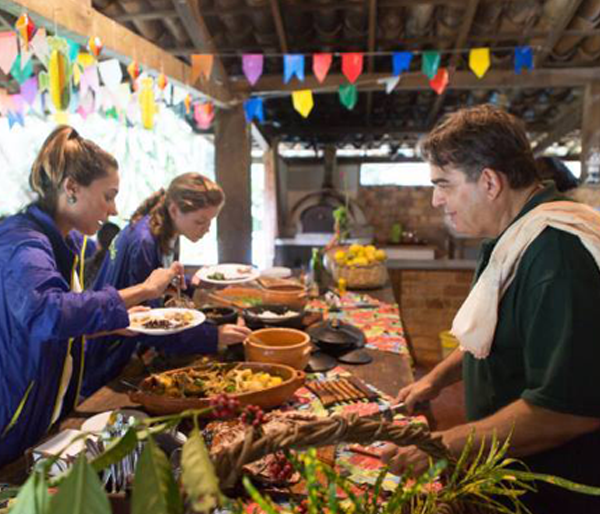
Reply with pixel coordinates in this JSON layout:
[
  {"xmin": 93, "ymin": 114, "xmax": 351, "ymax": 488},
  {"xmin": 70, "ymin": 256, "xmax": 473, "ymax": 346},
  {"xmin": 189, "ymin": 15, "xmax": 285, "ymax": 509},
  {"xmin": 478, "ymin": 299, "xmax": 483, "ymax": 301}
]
[{"xmin": 581, "ymin": 80, "xmax": 600, "ymax": 184}]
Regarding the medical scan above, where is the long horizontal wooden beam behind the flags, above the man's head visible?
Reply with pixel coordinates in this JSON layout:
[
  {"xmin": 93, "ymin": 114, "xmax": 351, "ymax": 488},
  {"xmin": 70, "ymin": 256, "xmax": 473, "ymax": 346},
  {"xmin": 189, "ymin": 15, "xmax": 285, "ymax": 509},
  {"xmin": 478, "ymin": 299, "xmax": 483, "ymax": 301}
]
[{"xmin": 231, "ymin": 68, "xmax": 598, "ymax": 96}]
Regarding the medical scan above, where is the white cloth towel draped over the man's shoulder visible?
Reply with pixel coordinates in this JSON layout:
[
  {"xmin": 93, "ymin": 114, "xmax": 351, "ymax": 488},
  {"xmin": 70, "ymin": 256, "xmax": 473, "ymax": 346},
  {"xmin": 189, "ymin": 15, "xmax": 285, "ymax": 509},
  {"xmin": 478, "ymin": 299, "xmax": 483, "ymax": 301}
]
[{"xmin": 451, "ymin": 201, "xmax": 600, "ymax": 359}]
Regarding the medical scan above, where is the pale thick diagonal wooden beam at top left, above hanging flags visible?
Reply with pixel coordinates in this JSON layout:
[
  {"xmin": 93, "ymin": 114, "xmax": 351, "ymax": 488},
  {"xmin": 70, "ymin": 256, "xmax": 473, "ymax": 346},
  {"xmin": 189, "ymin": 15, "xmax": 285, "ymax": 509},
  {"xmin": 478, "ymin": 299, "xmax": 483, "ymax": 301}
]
[{"xmin": 0, "ymin": 0, "xmax": 232, "ymax": 106}]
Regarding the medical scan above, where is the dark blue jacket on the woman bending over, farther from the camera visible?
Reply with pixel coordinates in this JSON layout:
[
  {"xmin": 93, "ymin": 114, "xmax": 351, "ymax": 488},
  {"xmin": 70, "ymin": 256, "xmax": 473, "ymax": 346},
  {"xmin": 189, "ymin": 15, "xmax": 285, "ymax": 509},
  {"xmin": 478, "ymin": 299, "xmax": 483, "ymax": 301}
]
[{"xmin": 82, "ymin": 216, "xmax": 218, "ymax": 396}]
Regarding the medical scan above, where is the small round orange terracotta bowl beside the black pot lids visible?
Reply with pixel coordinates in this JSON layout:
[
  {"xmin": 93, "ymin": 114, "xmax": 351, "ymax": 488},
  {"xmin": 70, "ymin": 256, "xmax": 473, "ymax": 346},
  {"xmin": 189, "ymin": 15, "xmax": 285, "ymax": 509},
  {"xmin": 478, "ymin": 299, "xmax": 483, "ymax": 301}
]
[{"xmin": 244, "ymin": 328, "xmax": 312, "ymax": 370}]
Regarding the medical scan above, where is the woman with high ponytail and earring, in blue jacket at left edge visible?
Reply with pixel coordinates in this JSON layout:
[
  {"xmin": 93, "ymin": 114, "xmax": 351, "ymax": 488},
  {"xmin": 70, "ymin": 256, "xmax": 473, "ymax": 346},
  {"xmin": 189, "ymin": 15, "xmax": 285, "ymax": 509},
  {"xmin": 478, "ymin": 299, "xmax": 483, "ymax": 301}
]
[{"xmin": 0, "ymin": 126, "xmax": 182, "ymax": 466}]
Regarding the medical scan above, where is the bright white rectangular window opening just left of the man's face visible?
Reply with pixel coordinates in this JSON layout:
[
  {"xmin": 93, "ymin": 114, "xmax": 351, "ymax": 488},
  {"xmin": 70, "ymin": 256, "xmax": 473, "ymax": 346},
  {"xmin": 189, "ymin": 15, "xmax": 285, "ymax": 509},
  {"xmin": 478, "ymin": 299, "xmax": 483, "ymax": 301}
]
[{"xmin": 360, "ymin": 162, "xmax": 432, "ymax": 186}]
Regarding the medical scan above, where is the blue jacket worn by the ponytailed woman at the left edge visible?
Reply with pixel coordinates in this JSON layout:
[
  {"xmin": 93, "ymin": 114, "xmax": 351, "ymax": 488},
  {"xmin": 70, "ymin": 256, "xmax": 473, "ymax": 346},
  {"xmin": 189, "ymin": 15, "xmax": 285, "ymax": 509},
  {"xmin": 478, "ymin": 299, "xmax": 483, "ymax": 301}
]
[{"xmin": 0, "ymin": 206, "xmax": 129, "ymax": 466}]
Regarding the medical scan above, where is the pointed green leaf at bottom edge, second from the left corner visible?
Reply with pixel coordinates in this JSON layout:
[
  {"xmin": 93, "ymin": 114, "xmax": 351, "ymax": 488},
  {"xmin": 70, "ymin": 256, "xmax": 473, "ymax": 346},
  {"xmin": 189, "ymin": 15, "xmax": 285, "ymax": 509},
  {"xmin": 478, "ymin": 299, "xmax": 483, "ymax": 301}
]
[{"xmin": 48, "ymin": 454, "xmax": 111, "ymax": 514}]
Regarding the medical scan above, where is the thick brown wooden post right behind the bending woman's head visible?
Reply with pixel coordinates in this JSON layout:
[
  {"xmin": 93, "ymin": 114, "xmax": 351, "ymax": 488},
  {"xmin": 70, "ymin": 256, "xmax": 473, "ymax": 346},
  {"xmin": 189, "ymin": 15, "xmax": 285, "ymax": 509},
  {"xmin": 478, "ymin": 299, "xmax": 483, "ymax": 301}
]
[{"xmin": 215, "ymin": 105, "xmax": 252, "ymax": 264}]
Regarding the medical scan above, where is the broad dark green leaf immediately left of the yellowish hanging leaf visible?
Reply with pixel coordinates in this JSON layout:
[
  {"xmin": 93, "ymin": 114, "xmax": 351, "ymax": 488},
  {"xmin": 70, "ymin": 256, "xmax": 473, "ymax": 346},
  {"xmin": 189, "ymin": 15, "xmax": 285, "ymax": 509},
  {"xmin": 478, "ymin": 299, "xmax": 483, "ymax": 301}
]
[{"xmin": 131, "ymin": 437, "xmax": 183, "ymax": 514}]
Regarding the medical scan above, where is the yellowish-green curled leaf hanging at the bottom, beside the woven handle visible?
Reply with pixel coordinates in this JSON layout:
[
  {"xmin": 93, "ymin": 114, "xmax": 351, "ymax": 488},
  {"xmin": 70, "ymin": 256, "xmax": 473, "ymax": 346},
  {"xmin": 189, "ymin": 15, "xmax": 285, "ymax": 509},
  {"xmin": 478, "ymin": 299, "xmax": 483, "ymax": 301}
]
[{"xmin": 181, "ymin": 428, "xmax": 221, "ymax": 512}]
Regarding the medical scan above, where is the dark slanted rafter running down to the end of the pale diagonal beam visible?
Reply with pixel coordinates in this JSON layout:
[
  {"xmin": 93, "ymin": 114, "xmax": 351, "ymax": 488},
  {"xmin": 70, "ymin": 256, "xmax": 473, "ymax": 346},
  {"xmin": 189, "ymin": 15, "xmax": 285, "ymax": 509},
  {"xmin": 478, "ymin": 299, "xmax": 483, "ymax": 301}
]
[{"xmin": 173, "ymin": 0, "xmax": 229, "ymax": 88}]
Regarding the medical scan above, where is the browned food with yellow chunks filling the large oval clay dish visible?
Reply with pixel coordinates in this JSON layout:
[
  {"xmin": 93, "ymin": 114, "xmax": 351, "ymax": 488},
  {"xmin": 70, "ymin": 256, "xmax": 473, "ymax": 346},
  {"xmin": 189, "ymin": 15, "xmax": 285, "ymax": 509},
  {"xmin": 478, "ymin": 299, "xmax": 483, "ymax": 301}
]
[{"xmin": 149, "ymin": 363, "xmax": 283, "ymax": 398}]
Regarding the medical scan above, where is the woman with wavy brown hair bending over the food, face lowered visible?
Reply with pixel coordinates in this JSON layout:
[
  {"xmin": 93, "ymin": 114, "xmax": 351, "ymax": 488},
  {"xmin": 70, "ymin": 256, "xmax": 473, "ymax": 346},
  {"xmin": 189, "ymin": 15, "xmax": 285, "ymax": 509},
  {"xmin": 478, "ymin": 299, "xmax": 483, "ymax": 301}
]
[{"xmin": 83, "ymin": 173, "xmax": 250, "ymax": 395}]
